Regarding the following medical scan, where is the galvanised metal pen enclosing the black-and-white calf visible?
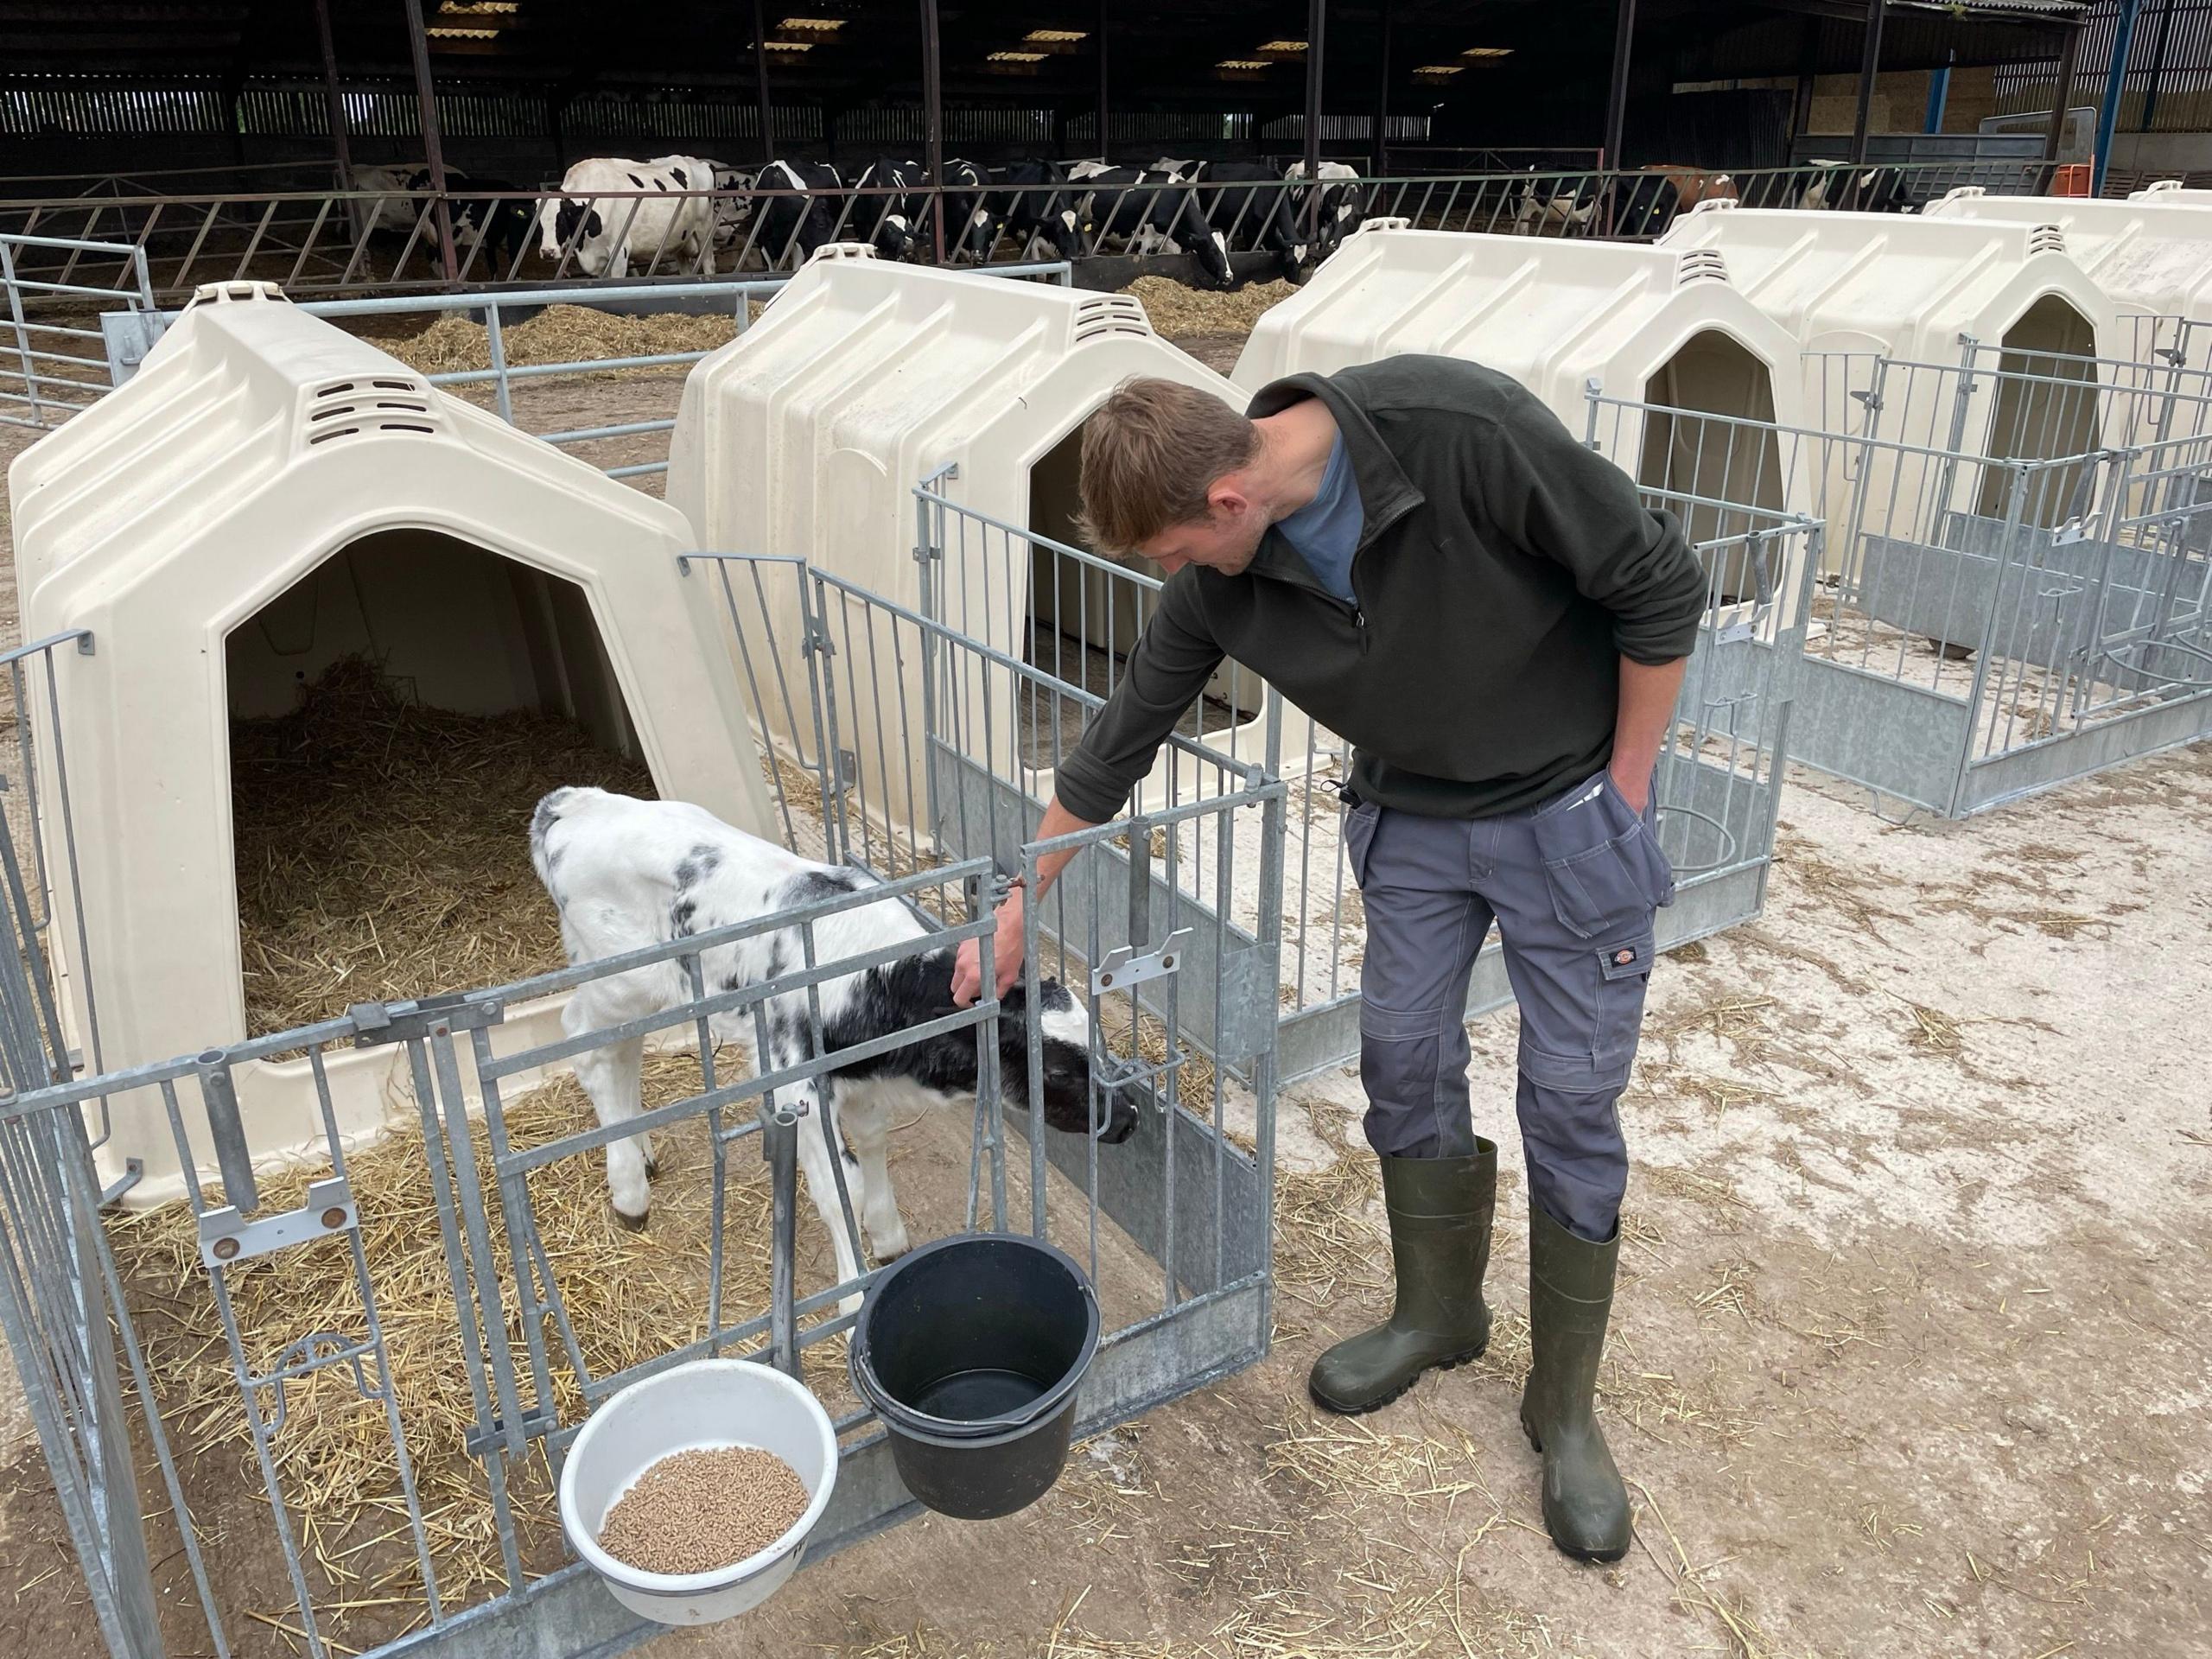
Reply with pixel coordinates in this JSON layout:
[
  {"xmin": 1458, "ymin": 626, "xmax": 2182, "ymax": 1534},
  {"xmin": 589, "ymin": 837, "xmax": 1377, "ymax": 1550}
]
[{"xmin": 0, "ymin": 556, "xmax": 1285, "ymax": 1659}]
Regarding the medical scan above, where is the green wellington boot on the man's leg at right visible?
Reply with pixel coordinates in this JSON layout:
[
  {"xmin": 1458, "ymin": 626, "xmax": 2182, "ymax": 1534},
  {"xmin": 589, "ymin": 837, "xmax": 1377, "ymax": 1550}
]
[{"xmin": 1522, "ymin": 1205, "xmax": 1628, "ymax": 1561}]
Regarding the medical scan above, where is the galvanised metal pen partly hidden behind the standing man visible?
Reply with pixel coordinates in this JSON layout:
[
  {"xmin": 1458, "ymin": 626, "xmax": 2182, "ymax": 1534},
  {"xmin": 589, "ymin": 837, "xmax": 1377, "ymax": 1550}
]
[{"xmin": 916, "ymin": 407, "xmax": 1822, "ymax": 1077}]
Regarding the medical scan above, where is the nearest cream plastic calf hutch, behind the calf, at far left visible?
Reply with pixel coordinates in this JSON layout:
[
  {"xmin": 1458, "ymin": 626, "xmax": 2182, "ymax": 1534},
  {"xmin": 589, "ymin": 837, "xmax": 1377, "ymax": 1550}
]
[{"xmin": 9, "ymin": 285, "xmax": 770, "ymax": 1199}]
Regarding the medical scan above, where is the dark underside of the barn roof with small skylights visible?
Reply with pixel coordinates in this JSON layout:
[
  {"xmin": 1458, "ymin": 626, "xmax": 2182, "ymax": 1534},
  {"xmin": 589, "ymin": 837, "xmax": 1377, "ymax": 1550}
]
[{"xmin": 0, "ymin": 0, "xmax": 2086, "ymax": 111}]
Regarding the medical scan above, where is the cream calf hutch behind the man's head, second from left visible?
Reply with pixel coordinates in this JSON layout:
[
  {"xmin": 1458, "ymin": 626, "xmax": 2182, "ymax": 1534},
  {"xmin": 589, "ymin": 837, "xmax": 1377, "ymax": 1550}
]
[{"xmin": 668, "ymin": 245, "xmax": 1300, "ymax": 836}]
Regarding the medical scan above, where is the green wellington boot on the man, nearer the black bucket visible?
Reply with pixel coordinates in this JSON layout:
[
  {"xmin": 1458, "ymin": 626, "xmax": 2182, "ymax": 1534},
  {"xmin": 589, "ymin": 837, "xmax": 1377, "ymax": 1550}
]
[{"xmin": 1305, "ymin": 1137, "xmax": 1497, "ymax": 1414}]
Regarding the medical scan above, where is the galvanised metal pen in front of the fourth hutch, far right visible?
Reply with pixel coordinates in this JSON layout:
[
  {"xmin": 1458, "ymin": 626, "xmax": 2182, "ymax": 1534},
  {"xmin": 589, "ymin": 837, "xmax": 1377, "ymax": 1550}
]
[{"xmin": 1751, "ymin": 340, "xmax": 2212, "ymax": 817}]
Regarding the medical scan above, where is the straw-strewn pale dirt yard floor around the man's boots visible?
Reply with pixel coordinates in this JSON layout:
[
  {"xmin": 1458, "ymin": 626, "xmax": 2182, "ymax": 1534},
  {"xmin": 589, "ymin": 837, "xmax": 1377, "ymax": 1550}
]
[{"xmin": 0, "ymin": 305, "xmax": 2212, "ymax": 1659}]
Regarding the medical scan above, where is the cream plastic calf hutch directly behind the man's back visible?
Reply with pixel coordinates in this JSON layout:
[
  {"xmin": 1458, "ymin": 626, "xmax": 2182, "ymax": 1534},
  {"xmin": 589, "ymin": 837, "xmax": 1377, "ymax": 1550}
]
[{"xmin": 1232, "ymin": 221, "xmax": 1809, "ymax": 546}]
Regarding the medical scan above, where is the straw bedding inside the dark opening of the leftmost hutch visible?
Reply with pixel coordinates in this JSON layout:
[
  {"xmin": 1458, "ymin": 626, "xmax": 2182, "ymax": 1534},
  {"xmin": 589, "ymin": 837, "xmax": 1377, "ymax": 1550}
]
[{"xmin": 230, "ymin": 657, "xmax": 652, "ymax": 1035}]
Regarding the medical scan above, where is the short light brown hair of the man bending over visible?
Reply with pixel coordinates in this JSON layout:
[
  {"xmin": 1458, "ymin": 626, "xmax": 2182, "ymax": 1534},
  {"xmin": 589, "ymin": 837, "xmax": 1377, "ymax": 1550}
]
[{"xmin": 1077, "ymin": 376, "xmax": 1259, "ymax": 556}]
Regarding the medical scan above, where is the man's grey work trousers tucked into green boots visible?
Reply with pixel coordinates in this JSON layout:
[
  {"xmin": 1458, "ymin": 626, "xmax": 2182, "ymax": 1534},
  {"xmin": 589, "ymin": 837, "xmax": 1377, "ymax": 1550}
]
[{"xmin": 1344, "ymin": 772, "xmax": 1675, "ymax": 1241}]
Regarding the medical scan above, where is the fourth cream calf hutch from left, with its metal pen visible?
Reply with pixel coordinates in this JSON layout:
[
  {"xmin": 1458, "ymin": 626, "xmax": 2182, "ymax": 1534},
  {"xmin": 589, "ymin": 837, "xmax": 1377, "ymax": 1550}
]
[{"xmin": 1659, "ymin": 201, "xmax": 2201, "ymax": 814}]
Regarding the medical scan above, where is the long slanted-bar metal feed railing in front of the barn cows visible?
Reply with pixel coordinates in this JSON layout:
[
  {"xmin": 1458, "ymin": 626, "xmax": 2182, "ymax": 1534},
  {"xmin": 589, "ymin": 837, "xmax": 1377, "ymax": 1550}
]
[{"xmin": 0, "ymin": 159, "xmax": 2049, "ymax": 301}]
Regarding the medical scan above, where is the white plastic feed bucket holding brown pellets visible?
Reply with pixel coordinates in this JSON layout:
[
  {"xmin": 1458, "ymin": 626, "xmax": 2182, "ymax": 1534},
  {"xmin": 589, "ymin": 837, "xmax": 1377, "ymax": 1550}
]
[{"xmin": 560, "ymin": 1360, "xmax": 838, "ymax": 1624}]
